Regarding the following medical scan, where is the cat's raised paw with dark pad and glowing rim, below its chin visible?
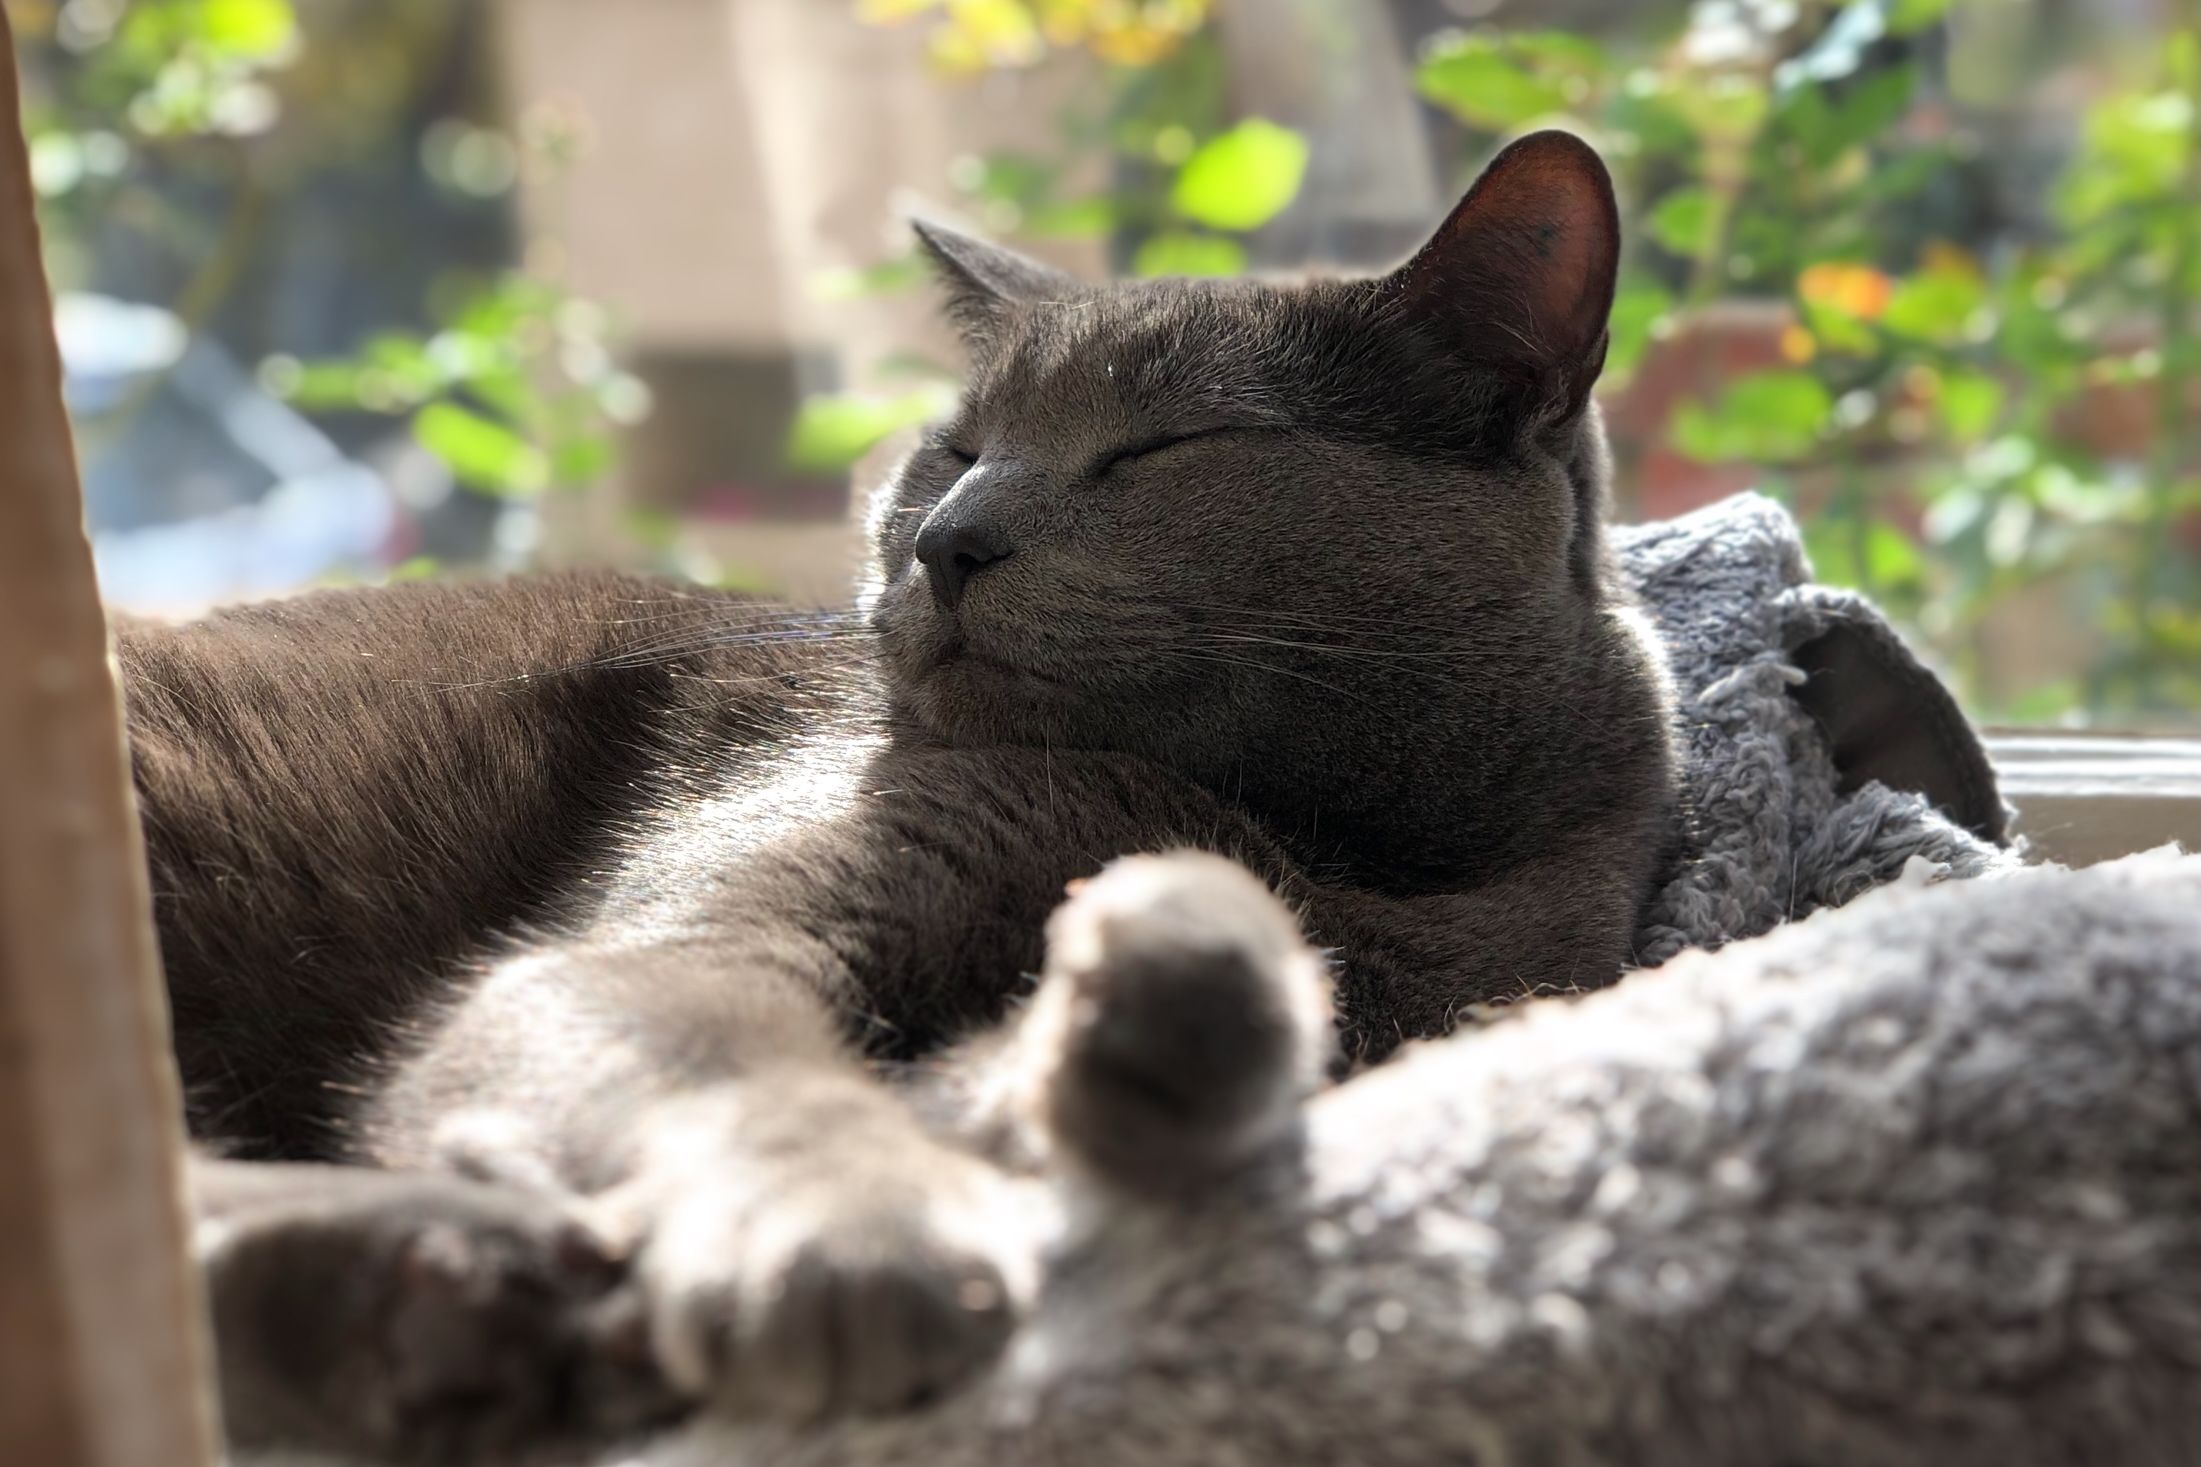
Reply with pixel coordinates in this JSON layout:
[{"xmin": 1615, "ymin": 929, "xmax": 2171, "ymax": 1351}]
[{"xmin": 1019, "ymin": 851, "xmax": 1334, "ymax": 1192}]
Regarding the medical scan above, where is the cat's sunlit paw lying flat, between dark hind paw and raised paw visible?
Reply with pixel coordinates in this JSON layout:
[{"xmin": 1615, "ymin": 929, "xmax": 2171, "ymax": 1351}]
[{"xmin": 620, "ymin": 1084, "xmax": 1034, "ymax": 1421}]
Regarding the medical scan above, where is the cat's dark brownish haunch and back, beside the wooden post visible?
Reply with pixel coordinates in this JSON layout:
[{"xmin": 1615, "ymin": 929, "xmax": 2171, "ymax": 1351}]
[{"xmin": 117, "ymin": 572, "xmax": 817, "ymax": 1159}]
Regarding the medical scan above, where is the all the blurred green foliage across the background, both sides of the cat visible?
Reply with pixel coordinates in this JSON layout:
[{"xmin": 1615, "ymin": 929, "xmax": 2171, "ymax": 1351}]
[{"xmin": 4, "ymin": 0, "xmax": 2201, "ymax": 721}]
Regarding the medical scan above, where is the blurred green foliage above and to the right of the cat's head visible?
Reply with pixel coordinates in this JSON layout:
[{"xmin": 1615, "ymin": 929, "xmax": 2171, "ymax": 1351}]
[{"xmin": 843, "ymin": 0, "xmax": 2201, "ymax": 721}]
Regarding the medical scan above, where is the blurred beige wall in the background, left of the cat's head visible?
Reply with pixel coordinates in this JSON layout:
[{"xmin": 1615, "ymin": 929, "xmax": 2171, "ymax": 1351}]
[{"xmin": 482, "ymin": 0, "xmax": 1105, "ymax": 598}]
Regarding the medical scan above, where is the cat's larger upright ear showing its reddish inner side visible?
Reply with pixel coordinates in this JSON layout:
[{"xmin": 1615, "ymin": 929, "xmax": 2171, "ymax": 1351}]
[{"xmin": 1387, "ymin": 132, "xmax": 1620, "ymax": 422}]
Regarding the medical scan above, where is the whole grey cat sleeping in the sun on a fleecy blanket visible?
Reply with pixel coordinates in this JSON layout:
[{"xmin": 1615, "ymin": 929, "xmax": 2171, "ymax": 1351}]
[{"xmin": 121, "ymin": 134, "xmax": 1671, "ymax": 1460}]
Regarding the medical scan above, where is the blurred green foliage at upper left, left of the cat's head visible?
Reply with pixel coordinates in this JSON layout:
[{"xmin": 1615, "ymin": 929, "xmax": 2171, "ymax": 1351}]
[{"xmin": 7, "ymin": 0, "xmax": 649, "ymax": 534}]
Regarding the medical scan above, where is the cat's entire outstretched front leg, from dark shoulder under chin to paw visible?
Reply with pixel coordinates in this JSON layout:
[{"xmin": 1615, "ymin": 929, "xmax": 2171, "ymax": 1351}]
[{"xmin": 361, "ymin": 748, "xmax": 1302, "ymax": 1419}]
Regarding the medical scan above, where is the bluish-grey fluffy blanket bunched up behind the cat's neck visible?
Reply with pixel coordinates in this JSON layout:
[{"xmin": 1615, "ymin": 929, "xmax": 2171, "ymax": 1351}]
[{"xmin": 1618, "ymin": 495, "xmax": 2014, "ymax": 963}]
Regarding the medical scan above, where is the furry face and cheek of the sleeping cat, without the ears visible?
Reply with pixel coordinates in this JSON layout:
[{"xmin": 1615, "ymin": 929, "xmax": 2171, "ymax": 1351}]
[{"xmin": 867, "ymin": 282, "xmax": 1666, "ymax": 886}]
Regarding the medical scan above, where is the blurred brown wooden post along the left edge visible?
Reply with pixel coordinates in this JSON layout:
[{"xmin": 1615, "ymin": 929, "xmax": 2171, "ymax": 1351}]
[{"xmin": 0, "ymin": 11, "xmax": 216, "ymax": 1467}]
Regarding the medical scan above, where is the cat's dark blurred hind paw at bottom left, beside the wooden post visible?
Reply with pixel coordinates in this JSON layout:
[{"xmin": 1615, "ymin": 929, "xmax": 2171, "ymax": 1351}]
[{"xmin": 189, "ymin": 1157, "xmax": 680, "ymax": 1467}]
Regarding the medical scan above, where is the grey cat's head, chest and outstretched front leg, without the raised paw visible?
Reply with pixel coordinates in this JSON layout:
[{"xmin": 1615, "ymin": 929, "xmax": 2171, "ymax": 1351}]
[{"xmin": 325, "ymin": 134, "xmax": 1671, "ymax": 1419}]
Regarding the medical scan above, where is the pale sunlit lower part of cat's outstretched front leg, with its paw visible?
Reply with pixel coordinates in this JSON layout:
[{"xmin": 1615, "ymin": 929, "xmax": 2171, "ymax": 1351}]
[{"xmin": 372, "ymin": 930, "xmax": 1037, "ymax": 1421}]
